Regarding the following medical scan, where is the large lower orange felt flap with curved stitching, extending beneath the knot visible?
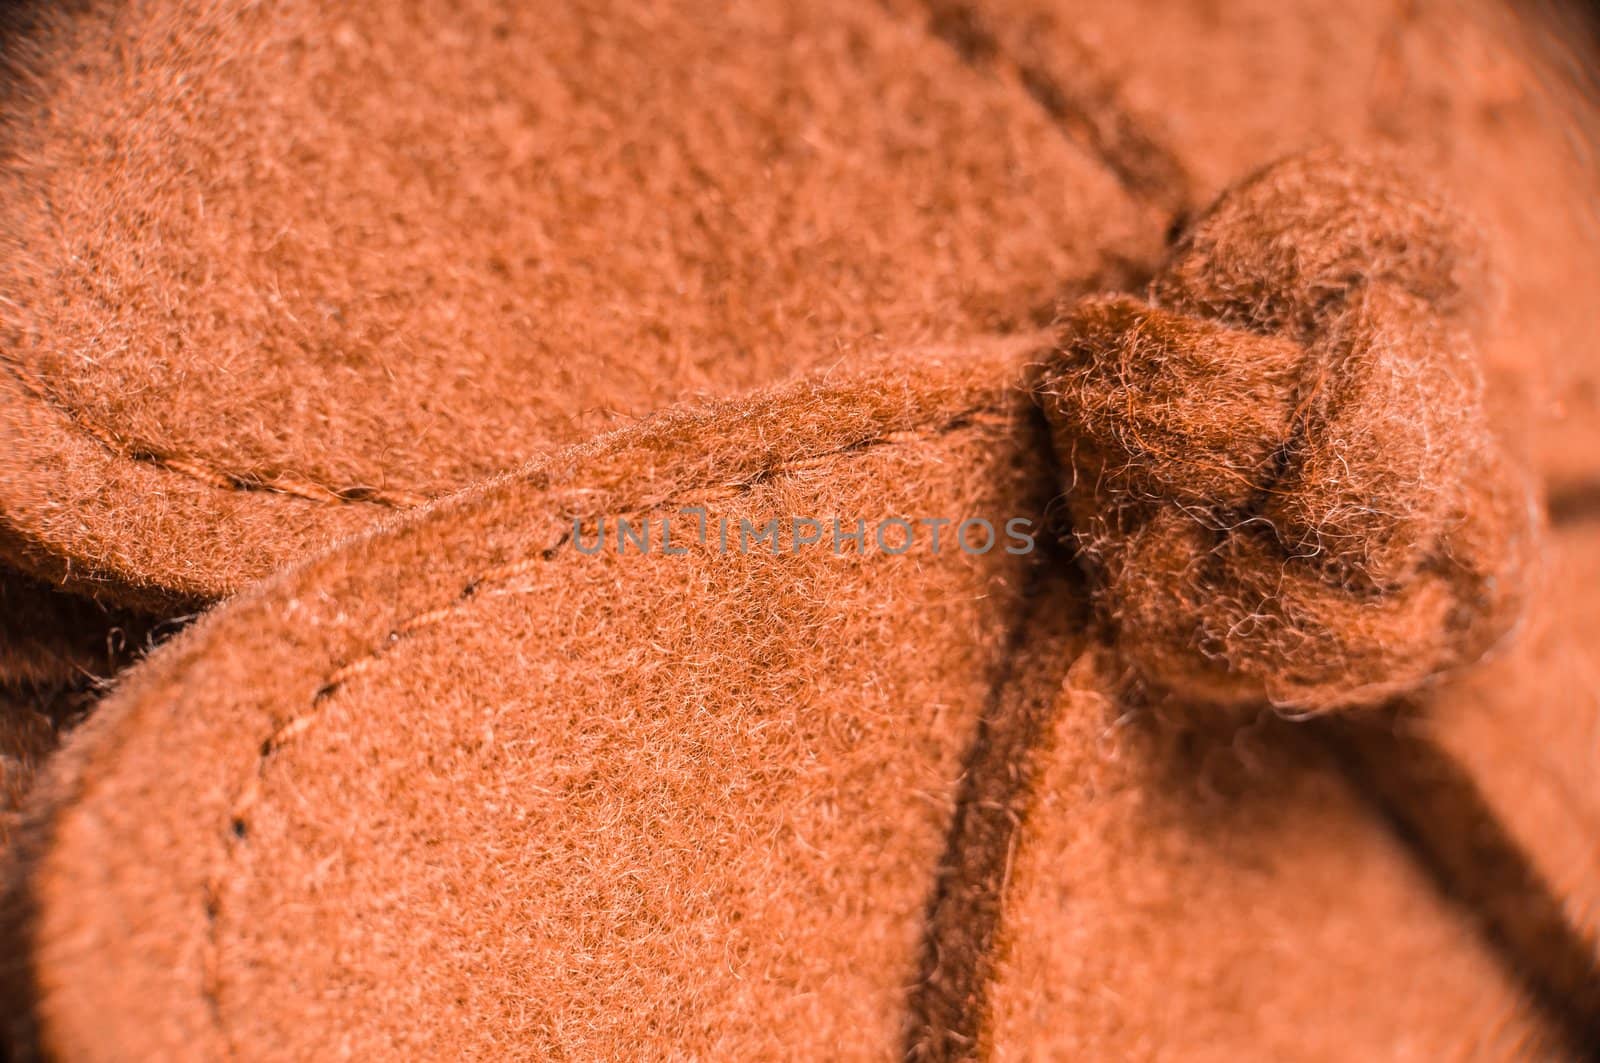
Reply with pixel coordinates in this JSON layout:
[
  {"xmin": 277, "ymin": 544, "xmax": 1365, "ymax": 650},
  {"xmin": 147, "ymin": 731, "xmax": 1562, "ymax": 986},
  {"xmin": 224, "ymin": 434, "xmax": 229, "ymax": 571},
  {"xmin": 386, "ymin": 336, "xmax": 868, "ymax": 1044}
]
[{"xmin": 8, "ymin": 352, "xmax": 1574, "ymax": 1058}]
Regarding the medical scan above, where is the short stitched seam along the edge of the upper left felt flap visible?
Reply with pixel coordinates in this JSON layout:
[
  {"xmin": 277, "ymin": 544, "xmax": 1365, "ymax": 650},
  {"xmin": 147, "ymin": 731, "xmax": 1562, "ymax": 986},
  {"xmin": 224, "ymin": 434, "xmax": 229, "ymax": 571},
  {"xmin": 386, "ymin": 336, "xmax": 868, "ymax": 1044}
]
[{"xmin": 0, "ymin": 352, "xmax": 429, "ymax": 509}]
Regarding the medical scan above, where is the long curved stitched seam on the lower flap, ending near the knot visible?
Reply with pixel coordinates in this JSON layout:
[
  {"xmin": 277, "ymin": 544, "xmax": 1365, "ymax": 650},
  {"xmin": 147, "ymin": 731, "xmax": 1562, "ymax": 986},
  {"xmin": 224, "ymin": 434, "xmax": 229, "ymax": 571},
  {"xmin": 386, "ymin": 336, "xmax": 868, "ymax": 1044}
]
[{"xmin": 202, "ymin": 407, "xmax": 1014, "ymax": 1057}]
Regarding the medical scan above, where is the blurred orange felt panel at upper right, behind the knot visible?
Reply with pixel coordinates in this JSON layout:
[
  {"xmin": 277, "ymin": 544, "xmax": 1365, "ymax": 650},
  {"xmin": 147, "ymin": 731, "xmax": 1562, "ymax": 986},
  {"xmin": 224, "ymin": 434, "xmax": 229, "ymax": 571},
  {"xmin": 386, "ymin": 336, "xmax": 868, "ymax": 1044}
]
[{"xmin": 909, "ymin": 0, "xmax": 1600, "ymax": 495}]
